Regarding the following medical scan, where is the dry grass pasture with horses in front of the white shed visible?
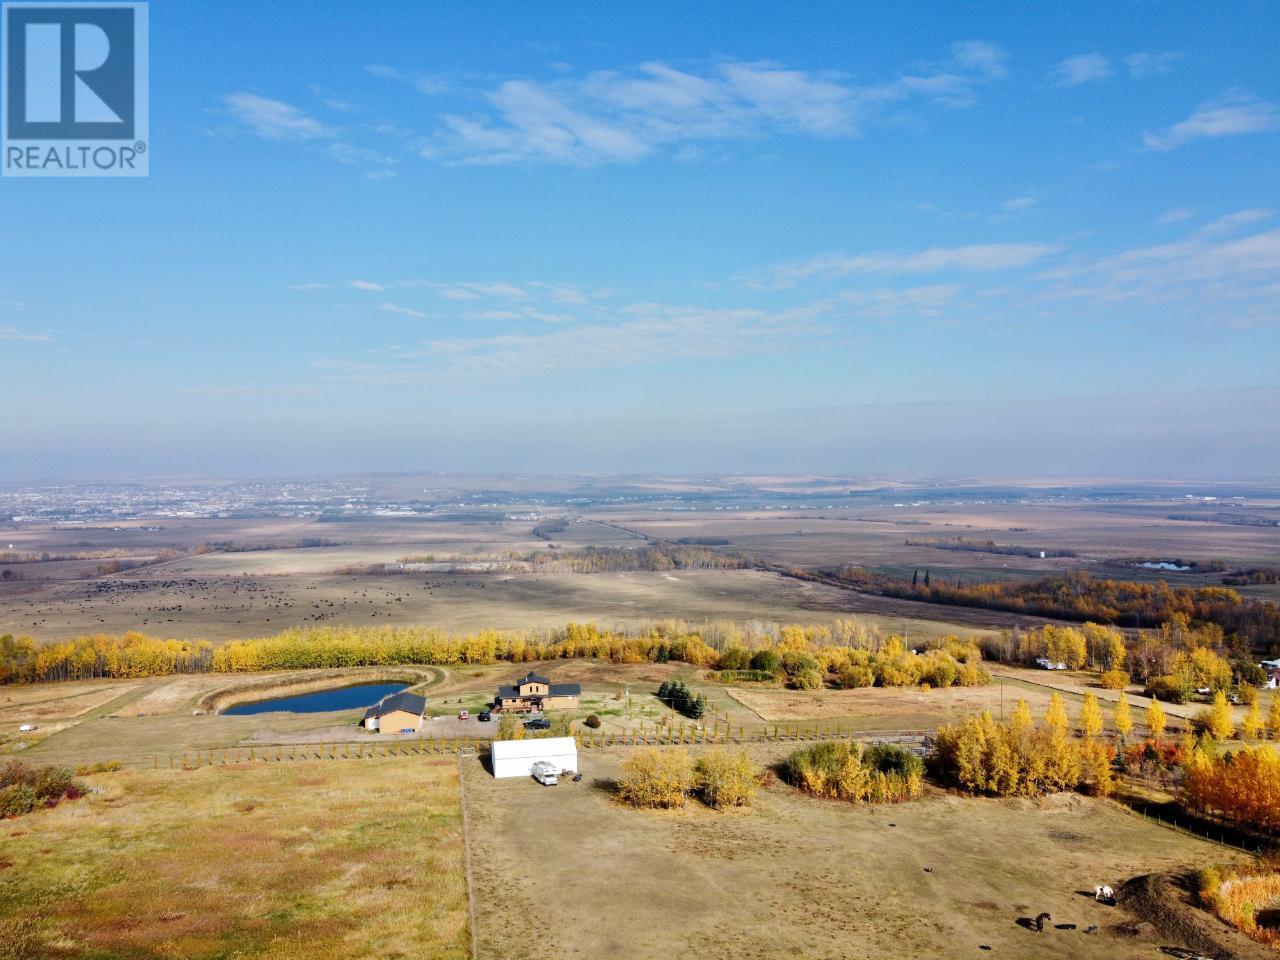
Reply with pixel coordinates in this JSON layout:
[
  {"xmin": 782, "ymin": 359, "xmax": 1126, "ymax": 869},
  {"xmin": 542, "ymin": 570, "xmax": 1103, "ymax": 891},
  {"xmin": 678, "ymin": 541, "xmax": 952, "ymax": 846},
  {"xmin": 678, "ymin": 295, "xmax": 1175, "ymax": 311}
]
[{"xmin": 466, "ymin": 745, "xmax": 1244, "ymax": 960}]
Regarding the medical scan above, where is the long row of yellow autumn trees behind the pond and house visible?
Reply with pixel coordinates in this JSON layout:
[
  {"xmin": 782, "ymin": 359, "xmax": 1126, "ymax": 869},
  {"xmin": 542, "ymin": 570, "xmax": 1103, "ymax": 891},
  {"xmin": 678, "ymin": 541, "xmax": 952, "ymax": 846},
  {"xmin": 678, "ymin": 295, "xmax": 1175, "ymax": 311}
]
[{"xmin": 0, "ymin": 621, "xmax": 988, "ymax": 687}]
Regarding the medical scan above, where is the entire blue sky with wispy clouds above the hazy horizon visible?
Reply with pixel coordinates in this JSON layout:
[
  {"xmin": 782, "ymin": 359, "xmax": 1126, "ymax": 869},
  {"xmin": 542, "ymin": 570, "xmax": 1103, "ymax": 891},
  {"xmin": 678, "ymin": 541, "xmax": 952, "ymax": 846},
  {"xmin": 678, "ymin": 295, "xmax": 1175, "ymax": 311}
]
[{"xmin": 0, "ymin": 0, "xmax": 1280, "ymax": 477}]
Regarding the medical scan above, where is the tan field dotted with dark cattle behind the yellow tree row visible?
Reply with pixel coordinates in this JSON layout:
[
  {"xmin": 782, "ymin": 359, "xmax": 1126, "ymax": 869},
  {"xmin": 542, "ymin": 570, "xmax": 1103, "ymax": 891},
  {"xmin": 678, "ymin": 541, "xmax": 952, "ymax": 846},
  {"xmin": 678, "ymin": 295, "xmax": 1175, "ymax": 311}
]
[{"xmin": 0, "ymin": 570, "xmax": 1003, "ymax": 641}]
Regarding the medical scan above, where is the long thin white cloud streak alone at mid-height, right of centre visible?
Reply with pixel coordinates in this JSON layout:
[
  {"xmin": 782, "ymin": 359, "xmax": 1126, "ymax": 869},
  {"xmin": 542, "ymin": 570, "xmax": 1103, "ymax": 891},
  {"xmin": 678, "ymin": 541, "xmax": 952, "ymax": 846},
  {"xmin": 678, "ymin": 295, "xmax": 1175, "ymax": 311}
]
[{"xmin": 748, "ymin": 243, "xmax": 1059, "ymax": 289}]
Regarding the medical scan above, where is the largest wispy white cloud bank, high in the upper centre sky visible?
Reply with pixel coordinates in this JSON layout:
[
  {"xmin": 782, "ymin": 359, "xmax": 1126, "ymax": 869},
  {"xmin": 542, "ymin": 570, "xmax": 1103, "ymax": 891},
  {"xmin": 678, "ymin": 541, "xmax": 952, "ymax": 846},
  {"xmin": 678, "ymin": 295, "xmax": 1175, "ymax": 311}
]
[{"xmin": 399, "ymin": 41, "xmax": 1006, "ymax": 166}]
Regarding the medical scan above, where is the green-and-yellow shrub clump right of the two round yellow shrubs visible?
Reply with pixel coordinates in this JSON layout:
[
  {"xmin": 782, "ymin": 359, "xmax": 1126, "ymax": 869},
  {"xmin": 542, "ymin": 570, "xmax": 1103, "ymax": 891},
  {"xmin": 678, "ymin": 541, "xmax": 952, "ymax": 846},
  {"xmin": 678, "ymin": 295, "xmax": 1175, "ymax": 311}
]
[{"xmin": 782, "ymin": 741, "xmax": 924, "ymax": 803}]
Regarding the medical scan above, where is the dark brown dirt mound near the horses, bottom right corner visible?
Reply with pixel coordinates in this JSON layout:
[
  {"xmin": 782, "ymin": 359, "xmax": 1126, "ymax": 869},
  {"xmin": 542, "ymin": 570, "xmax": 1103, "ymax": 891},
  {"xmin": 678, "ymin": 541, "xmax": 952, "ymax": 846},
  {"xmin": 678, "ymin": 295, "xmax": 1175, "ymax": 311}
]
[{"xmin": 1116, "ymin": 873, "xmax": 1276, "ymax": 960}]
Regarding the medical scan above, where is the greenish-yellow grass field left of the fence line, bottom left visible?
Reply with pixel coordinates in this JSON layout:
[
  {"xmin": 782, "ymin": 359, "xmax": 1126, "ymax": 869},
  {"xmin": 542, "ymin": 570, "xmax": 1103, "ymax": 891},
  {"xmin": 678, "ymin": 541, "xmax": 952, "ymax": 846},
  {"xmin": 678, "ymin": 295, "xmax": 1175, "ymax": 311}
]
[{"xmin": 0, "ymin": 758, "xmax": 471, "ymax": 960}]
